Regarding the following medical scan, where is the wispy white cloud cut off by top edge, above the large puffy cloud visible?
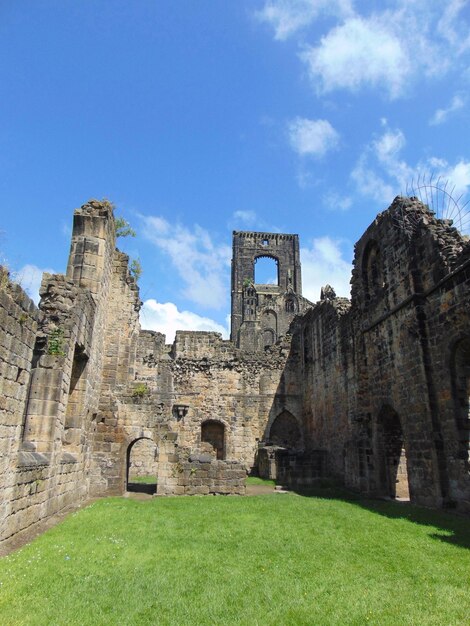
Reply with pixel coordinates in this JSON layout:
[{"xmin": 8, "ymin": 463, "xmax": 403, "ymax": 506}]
[{"xmin": 255, "ymin": 0, "xmax": 353, "ymax": 41}]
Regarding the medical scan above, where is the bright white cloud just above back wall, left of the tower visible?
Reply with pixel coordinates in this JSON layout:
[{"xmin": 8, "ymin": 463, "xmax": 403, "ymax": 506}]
[{"xmin": 140, "ymin": 299, "xmax": 229, "ymax": 343}]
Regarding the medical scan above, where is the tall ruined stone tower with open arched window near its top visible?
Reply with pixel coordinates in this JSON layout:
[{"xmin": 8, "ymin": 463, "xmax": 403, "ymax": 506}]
[{"xmin": 231, "ymin": 231, "xmax": 311, "ymax": 351}]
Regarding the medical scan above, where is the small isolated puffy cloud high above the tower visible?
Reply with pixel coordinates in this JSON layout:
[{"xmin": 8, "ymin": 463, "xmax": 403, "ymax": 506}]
[{"xmin": 288, "ymin": 117, "xmax": 339, "ymax": 157}]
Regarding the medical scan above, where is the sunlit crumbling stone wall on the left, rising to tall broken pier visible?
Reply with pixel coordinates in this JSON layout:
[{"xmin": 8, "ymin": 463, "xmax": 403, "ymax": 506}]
[{"xmin": 0, "ymin": 201, "xmax": 140, "ymax": 540}]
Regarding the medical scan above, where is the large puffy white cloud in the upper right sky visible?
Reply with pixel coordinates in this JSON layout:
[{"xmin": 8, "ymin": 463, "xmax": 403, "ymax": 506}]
[{"xmin": 301, "ymin": 17, "xmax": 410, "ymax": 97}]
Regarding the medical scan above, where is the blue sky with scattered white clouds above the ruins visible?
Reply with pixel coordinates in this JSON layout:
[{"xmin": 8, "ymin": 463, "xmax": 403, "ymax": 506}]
[{"xmin": 0, "ymin": 0, "xmax": 470, "ymax": 339}]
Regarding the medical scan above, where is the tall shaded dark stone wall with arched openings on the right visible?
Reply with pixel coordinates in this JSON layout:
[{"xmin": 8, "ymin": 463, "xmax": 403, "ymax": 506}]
[{"xmin": 299, "ymin": 198, "xmax": 470, "ymax": 510}]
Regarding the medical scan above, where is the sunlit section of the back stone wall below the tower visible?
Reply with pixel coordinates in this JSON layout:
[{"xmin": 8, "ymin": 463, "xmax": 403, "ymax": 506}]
[{"xmin": 98, "ymin": 331, "xmax": 301, "ymax": 494}]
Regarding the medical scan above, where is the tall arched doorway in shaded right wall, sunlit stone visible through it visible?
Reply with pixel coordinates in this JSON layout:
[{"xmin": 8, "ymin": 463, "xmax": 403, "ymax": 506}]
[{"xmin": 377, "ymin": 406, "xmax": 410, "ymax": 500}]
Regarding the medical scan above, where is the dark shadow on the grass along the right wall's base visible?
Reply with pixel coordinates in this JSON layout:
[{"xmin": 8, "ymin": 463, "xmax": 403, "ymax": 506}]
[{"xmin": 291, "ymin": 486, "xmax": 470, "ymax": 550}]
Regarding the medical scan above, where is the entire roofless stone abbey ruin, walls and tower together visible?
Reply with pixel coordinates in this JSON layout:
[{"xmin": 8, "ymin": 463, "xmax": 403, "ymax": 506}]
[{"xmin": 0, "ymin": 197, "xmax": 470, "ymax": 541}]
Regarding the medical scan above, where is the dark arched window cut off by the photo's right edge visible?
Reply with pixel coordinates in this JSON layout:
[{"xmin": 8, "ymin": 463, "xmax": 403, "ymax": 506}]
[{"xmin": 452, "ymin": 337, "xmax": 470, "ymax": 463}]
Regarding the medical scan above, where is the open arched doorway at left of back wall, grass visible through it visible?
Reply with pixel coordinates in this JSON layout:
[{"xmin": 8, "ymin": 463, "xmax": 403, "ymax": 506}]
[{"xmin": 126, "ymin": 437, "xmax": 158, "ymax": 494}]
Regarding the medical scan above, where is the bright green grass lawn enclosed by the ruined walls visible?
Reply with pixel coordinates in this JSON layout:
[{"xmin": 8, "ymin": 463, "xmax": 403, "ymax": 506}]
[{"xmin": 0, "ymin": 494, "xmax": 470, "ymax": 626}]
